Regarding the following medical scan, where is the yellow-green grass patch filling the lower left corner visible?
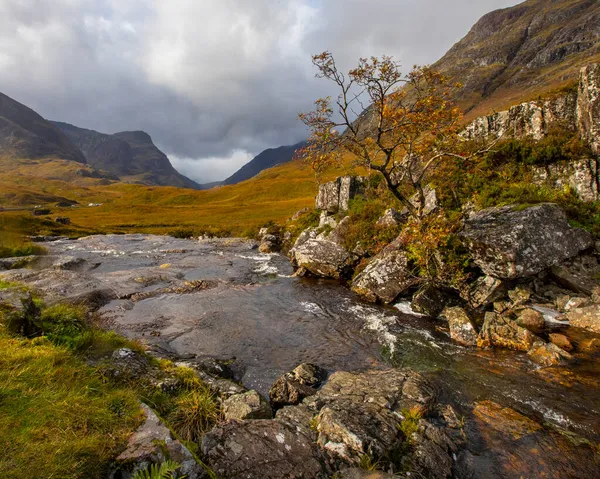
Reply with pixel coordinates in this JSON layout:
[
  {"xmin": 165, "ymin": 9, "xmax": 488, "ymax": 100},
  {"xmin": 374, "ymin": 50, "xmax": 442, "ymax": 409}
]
[{"xmin": 0, "ymin": 328, "xmax": 141, "ymax": 479}]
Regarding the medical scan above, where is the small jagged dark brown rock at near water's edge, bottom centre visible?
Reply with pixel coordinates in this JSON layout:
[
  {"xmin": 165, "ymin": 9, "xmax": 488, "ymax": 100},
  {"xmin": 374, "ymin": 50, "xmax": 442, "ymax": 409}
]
[{"xmin": 269, "ymin": 363, "xmax": 327, "ymax": 408}]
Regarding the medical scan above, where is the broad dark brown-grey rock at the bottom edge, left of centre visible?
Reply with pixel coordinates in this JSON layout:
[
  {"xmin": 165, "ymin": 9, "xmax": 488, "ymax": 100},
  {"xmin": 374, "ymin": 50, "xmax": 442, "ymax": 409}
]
[{"xmin": 201, "ymin": 419, "xmax": 331, "ymax": 479}]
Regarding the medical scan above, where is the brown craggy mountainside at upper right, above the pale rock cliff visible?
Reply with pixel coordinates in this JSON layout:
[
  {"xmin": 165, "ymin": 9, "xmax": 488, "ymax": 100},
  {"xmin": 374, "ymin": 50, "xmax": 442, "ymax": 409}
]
[{"xmin": 433, "ymin": 0, "xmax": 600, "ymax": 117}]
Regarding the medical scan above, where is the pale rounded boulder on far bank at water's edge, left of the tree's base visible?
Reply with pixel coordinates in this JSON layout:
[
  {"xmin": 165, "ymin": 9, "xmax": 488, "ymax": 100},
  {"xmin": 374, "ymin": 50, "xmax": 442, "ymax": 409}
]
[{"xmin": 290, "ymin": 239, "xmax": 357, "ymax": 279}]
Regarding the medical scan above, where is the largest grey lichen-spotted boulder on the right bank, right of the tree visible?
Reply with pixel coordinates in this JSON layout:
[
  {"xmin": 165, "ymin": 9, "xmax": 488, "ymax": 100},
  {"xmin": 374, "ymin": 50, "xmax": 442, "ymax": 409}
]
[{"xmin": 461, "ymin": 203, "xmax": 593, "ymax": 279}]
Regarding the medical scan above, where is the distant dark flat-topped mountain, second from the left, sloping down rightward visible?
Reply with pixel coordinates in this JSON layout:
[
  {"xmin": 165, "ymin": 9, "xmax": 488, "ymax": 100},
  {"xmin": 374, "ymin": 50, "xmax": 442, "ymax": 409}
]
[{"xmin": 52, "ymin": 121, "xmax": 200, "ymax": 189}]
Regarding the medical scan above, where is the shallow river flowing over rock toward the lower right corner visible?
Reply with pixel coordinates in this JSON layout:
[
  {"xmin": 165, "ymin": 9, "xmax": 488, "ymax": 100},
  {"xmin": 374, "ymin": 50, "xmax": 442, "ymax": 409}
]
[{"xmin": 31, "ymin": 235, "xmax": 600, "ymax": 477}]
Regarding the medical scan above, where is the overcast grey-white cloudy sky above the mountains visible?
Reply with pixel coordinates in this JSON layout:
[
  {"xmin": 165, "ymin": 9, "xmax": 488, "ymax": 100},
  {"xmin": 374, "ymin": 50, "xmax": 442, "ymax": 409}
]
[{"xmin": 0, "ymin": 0, "xmax": 520, "ymax": 182}]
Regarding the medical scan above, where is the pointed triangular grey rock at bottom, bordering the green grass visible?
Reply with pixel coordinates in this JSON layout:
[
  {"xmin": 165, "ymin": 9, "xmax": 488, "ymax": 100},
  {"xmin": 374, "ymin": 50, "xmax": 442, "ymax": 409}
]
[{"xmin": 111, "ymin": 404, "xmax": 207, "ymax": 479}]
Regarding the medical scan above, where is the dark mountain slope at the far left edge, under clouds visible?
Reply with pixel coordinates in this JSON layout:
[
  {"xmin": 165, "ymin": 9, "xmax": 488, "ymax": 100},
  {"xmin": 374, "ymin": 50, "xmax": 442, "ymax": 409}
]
[{"xmin": 0, "ymin": 93, "xmax": 86, "ymax": 163}]
